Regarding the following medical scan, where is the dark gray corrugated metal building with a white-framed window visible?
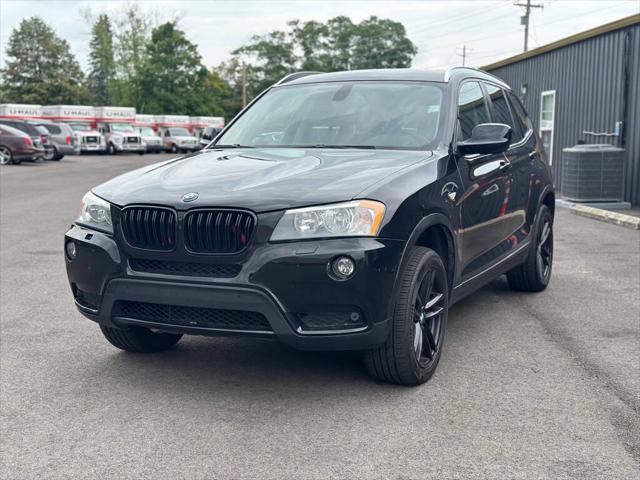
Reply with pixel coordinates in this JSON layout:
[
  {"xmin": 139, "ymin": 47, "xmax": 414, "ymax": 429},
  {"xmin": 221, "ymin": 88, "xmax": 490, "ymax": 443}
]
[{"xmin": 482, "ymin": 15, "xmax": 640, "ymax": 205}]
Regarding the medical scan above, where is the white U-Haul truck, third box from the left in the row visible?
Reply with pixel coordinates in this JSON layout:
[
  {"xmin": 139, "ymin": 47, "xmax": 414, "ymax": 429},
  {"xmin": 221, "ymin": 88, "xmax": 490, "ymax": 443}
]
[{"xmin": 96, "ymin": 107, "xmax": 146, "ymax": 155}]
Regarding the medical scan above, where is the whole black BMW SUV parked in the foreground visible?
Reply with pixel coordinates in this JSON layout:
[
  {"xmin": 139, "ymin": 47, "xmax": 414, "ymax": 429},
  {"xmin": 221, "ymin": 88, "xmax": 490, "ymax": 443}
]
[{"xmin": 65, "ymin": 68, "xmax": 554, "ymax": 385}]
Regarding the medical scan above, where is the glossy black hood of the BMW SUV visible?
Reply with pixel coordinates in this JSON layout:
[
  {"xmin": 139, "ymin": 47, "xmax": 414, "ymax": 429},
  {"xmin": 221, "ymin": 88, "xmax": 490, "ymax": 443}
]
[{"xmin": 93, "ymin": 148, "xmax": 432, "ymax": 212}]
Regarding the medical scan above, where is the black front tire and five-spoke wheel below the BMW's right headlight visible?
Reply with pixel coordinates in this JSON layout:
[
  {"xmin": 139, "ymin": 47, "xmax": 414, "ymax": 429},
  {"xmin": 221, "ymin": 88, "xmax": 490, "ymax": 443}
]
[{"xmin": 365, "ymin": 247, "xmax": 449, "ymax": 385}]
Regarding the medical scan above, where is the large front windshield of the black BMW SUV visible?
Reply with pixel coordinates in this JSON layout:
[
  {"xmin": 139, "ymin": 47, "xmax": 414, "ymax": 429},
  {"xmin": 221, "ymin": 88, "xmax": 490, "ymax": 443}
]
[{"xmin": 216, "ymin": 81, "xmax": 442, "ymax": 149}]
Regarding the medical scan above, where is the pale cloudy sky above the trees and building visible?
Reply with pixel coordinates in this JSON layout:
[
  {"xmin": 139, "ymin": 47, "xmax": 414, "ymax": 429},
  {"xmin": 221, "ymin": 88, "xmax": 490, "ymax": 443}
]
[{"xmin": 0, "ymin": 0, "xmax": 640, "ymax": 68}]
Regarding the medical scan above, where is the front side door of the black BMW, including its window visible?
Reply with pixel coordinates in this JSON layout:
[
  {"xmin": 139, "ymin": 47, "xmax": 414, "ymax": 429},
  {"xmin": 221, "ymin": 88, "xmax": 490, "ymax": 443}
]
[{"xmin": 457, "ymin": 80, "xmax": 517, "ymax": 281}]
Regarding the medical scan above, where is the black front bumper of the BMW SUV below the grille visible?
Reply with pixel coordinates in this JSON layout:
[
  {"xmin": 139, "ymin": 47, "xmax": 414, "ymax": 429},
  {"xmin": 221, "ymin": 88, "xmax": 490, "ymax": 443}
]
[{"xmin": 65, "ymin": 226, "xmax": 404, "ymax": 350}]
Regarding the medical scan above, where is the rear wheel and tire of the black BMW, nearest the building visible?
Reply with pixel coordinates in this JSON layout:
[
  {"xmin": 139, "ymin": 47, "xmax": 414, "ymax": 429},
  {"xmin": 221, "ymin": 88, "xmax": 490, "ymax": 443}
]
[{"xmin": 507, "ymin": 205, "xmax": 553, "ymax": 292}]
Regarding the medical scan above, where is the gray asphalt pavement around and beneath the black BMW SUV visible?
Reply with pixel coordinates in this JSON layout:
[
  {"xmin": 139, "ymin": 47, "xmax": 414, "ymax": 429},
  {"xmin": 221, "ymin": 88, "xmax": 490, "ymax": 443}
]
[{"xmin": 0, "ymin": 155, "xmax": 640, "ymax": 479}]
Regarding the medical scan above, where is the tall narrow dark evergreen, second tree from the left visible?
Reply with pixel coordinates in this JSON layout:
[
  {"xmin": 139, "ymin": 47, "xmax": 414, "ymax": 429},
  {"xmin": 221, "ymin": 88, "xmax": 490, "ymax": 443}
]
[{"xmin": 87, "ymin": 14, "xmax": 116, "ymax": 105}]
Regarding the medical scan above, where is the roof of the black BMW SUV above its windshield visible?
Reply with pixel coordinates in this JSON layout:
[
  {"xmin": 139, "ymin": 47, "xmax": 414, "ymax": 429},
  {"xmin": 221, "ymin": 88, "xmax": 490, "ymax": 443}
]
[{"xmin": 276, "ymin": 67, "xmax": 504, "ymax": 85}]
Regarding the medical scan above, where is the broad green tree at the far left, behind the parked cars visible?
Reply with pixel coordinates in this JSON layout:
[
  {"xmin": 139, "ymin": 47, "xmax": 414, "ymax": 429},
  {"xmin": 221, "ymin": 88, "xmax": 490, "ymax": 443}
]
[{"xmin": 1, "ymin": 17, "xmax": 87, "ymax": 104}]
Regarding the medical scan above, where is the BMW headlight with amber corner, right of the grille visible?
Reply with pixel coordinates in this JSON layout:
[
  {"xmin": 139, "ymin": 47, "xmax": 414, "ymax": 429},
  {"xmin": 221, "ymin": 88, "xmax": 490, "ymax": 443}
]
[{"xmin": 271, "ymin": 200, "xmax": 385, "ymax": 241}]
